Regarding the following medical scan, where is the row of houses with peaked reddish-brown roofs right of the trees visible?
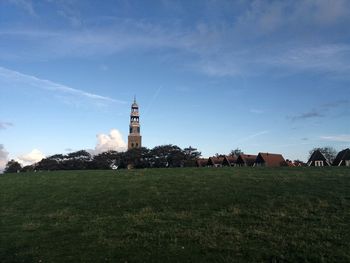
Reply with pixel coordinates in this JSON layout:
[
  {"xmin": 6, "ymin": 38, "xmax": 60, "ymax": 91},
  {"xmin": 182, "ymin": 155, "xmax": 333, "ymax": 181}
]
[{"xmin": 197, "ymin": 149, "xmax": 350, "ymax": 167}]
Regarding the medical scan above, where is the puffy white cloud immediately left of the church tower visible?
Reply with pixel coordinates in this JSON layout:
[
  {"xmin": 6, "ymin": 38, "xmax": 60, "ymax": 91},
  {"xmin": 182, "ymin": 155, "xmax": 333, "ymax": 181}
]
[{"xmin": 91, "ymin": 129, "xmax": 126, "ymax": 154}]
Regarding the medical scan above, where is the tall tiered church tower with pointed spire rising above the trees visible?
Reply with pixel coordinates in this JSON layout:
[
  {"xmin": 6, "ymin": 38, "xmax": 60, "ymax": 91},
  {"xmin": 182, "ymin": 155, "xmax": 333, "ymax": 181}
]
[{"xmin": 128, "ymin": 97, "xmax": 141, "ymax": 150}]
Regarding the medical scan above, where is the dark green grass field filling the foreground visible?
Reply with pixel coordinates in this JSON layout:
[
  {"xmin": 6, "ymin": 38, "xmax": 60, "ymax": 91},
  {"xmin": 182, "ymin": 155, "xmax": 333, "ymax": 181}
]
[{"xmin": 0, "ymin": 168, "xmax": 350, "ymax": 263}]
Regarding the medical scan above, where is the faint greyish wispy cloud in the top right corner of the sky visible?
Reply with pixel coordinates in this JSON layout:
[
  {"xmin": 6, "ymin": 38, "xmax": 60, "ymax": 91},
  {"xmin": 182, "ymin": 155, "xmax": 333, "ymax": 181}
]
[{"xmin": 232, "ymin": 0, "xmax": 350, "ymax": 37}]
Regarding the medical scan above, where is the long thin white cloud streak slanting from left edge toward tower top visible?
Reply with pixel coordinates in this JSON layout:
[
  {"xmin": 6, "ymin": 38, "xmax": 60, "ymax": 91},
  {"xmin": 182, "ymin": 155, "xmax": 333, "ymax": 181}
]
[{"xmin": 0, "ymin": 67, "xmax": 126, "ymax": 104}]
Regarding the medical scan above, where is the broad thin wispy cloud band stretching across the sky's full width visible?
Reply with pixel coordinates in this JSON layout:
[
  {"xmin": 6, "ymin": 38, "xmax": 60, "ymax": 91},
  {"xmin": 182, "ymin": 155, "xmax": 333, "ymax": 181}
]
[{"xmin": 0, "ymin": 28, "xmax": 350, "ymax": 77}]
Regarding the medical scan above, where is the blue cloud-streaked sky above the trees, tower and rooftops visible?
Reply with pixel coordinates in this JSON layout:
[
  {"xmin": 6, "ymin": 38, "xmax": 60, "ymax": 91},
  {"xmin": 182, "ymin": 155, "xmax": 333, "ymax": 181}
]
[{"xmin": 0, "ymin": 0, "xmax": 350, "ymax": 169}]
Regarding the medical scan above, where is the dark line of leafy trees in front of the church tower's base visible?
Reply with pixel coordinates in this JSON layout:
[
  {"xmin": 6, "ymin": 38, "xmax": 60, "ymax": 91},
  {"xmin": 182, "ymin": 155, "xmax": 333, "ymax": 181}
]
[{"xmin": 5, "ymin": 144, "xmax": 201, "ymax": 173}]
